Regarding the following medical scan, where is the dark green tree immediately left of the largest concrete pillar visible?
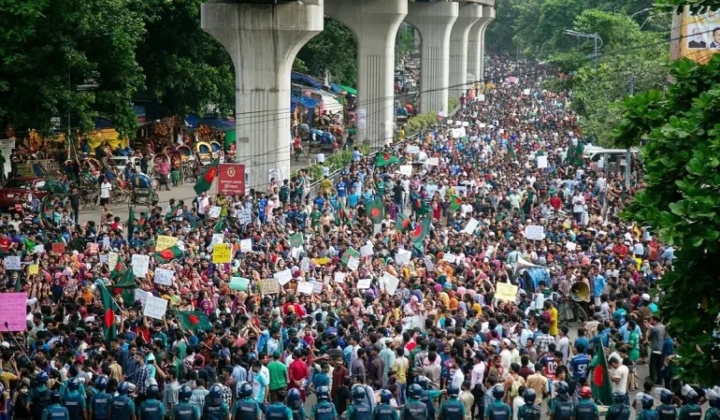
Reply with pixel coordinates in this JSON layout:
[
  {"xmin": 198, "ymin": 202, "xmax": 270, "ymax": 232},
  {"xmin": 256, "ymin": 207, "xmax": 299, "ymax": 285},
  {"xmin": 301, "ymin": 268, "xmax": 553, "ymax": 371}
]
[{"xmin": 137, "ymin": 0, "xmax": 235, "ymax": 115}]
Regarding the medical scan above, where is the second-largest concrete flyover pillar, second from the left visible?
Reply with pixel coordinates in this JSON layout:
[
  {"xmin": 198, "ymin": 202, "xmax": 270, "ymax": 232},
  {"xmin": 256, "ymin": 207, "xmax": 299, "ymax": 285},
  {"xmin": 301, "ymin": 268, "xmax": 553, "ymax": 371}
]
[{"xmin": 325, "ymin": 0, "xmax": 407, "ymax": 148}]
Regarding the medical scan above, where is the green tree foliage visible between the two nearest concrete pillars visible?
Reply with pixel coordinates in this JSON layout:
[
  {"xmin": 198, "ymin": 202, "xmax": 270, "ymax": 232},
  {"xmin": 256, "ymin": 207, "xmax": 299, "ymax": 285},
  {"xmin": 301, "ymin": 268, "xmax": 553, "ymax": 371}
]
[{"xmin": 297, "ymin": 18, "xmax": 357, "ymax": 86}]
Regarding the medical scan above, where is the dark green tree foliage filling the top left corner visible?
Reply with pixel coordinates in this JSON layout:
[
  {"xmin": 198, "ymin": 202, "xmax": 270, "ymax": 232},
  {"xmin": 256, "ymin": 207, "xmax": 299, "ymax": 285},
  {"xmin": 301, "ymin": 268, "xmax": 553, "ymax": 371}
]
[{"xmin": 0, "ymin": 0, "xmax": 145, "ymax": 133}]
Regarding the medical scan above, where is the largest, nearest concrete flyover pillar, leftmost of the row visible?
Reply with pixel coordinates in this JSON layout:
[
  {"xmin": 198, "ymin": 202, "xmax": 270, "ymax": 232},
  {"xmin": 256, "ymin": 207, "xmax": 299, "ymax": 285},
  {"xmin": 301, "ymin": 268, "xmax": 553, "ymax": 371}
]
[{"xmin": 201, "ymin": 0, "xmax": 323, "ymax": 190}]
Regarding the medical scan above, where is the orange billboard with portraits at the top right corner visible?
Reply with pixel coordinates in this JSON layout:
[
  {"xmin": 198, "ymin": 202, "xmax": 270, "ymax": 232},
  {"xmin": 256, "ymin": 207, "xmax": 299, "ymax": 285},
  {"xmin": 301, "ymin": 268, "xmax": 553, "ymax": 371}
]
[{"xmin": 679, "ymin": 7, "xmax": 720, "ymax": 64}]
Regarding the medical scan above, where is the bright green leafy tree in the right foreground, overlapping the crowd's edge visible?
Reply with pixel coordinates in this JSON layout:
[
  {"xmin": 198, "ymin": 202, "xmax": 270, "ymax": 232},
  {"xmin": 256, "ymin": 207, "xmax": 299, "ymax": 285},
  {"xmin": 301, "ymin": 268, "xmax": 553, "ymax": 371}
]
[{"xmin": 614, "ymin": 55, "xmax": 720, "ymax": 386}]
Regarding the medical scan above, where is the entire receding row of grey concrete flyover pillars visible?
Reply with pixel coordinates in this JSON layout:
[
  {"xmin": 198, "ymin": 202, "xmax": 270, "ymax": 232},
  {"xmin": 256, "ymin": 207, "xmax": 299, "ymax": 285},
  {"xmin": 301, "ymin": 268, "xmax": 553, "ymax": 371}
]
[{"xmin": 201, "ymin": 0, "xmax": 495, "ymax": 188}]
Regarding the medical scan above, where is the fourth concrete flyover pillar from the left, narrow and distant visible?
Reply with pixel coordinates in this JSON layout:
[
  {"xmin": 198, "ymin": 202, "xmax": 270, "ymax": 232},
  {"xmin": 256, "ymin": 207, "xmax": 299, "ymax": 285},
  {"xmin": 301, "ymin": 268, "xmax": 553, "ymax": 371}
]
[{"xmin": 450, "ymin": 3, "xmax": 482, "ymax": 98}]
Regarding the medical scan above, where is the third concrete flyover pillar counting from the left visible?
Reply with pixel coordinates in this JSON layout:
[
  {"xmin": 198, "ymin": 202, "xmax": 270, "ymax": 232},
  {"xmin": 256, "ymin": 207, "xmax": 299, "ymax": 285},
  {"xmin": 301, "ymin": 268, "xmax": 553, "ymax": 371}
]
[{"xmin": 405, "ymin": 2, "xmax": 458, "ymax": 115}]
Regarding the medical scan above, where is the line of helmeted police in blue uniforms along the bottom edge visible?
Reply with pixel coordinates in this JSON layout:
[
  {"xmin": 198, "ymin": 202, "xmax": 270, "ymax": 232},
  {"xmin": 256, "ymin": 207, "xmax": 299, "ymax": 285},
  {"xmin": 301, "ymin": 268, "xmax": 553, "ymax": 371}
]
[{"xmin": 22, "ymin": 372, "xmax": 720, "ymax": 420}]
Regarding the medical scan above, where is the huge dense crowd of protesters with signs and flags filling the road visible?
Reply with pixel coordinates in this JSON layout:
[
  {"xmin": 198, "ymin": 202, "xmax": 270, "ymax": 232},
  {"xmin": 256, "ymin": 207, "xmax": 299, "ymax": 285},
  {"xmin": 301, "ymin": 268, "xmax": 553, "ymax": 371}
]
[{"xmin": 0, "ymin": 57, "xmax": 720, "ymax": 420}]
